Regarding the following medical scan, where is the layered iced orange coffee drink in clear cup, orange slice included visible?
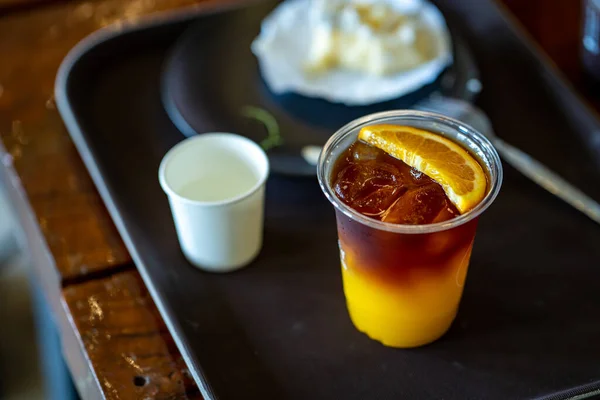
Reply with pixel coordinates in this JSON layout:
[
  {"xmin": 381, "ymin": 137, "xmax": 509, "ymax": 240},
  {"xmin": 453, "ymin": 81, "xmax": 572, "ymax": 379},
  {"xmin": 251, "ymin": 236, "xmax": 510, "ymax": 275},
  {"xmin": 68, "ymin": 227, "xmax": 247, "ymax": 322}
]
[{"xmin": 318, "ymin": 111, "xmax": 502, "ymax": 347}]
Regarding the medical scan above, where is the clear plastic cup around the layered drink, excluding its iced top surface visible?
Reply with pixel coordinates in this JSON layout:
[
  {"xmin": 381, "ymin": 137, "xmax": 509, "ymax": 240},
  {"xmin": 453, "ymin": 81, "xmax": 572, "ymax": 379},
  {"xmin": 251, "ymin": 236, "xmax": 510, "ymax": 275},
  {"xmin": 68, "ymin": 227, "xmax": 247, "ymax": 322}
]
[{"xmin": 318, "ymin": 111, "xmax": 502, "ymax": 347}]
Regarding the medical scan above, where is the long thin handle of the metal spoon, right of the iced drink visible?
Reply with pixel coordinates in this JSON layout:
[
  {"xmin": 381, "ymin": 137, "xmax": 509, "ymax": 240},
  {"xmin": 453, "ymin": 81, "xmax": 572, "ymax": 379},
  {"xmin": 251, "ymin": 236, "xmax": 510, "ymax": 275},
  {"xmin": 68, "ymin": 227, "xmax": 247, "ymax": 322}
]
[{"xmin": 493, "ymin": 138, "xmax": 600, "ymax": 224}]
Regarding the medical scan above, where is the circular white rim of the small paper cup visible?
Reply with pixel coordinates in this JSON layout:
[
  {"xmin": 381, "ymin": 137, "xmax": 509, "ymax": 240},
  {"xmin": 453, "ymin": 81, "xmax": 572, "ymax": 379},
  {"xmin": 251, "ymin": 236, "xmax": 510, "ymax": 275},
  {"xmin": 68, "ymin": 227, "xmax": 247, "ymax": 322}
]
[{"xmin": 158, "ymin": 132, "xmax": 270, "ymax": 207}]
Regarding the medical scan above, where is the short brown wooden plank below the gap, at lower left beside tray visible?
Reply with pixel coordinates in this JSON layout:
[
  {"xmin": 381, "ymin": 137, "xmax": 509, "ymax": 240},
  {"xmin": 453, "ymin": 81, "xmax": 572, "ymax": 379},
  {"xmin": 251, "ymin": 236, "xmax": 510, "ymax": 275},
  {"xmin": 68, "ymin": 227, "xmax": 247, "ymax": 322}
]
[{"xmin": 63, "ymin": 271, "xmax": 200, "ymax": 399}]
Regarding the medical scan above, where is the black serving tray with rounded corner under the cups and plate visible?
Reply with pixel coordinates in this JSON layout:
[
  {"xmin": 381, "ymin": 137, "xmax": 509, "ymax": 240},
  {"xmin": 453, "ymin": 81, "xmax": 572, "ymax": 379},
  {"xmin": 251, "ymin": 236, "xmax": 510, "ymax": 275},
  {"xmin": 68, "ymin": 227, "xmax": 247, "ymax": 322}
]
[{"xmin": 57, "ymin": 0, "xmax": 600, "ymax": 399}]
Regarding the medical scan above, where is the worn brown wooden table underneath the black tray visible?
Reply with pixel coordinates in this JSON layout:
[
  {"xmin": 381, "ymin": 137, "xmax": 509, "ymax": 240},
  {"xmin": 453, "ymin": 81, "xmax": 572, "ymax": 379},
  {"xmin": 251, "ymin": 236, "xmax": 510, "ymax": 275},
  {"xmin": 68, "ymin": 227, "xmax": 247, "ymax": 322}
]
[{"xmin": 0, "ymin": 0, "xmax": 598, "ymax": 399}]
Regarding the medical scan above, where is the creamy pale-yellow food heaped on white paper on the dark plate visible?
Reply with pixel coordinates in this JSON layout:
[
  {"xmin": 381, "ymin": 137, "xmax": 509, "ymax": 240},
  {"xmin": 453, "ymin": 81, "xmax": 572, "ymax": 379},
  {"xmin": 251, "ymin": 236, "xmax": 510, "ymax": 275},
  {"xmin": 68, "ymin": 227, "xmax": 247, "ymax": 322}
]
[{"xmin": 305, "ymin": 0, "xmax": 435, "ymax": 75}]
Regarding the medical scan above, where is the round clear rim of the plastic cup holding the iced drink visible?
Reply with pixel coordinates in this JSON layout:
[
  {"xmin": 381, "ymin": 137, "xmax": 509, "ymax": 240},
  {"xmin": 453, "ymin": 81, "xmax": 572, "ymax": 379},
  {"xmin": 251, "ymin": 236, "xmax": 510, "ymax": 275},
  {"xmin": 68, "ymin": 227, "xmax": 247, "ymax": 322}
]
[{"xmin": 317, "ymin": 110, "xmax": 503, "ymax": 234}]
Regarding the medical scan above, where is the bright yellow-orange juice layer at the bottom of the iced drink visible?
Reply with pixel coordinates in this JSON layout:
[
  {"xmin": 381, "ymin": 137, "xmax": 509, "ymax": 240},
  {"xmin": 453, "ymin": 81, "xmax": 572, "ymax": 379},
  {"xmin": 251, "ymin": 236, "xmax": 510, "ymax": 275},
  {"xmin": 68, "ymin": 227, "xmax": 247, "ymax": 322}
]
[{"xmin": 342, "ymin": 242, "xmax": 473, "ymax": 347}]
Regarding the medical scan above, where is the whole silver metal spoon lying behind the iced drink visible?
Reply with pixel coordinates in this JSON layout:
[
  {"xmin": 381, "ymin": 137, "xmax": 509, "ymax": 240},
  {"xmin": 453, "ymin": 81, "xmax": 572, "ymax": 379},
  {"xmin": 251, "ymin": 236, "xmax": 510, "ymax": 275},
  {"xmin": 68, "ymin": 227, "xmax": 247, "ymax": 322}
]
[{"xmin": 415, "ymin": 97, "xmax": 600, "ymax": 224}]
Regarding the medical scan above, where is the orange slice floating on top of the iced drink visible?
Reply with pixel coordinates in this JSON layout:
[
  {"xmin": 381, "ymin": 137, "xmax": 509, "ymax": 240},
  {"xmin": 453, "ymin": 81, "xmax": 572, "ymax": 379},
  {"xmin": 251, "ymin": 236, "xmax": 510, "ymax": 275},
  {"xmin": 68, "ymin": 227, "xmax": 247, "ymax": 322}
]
[{"xmin": 358, "ymin": 125, "xmax": 487, "ymax": 214}]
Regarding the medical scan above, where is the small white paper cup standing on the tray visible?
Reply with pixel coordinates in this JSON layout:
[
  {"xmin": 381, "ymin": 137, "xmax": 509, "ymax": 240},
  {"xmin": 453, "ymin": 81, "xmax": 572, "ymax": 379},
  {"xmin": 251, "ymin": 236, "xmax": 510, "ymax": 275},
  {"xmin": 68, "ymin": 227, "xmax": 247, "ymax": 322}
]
[{"xmin": 159, "ymin": 133, "xmax": 269, "ymax": 272}]
